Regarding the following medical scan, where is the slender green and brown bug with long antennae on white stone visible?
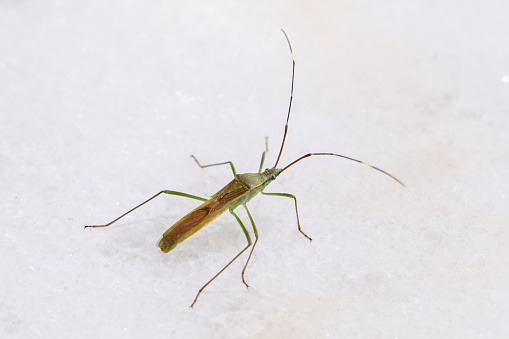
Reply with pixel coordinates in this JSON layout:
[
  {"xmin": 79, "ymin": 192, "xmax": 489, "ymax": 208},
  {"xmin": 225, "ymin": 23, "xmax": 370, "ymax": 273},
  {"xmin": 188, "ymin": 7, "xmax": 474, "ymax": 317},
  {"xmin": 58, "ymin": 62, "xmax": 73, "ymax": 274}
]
[{"xmin": 85, "ymin": 30, "xmax": 405, "ymax": 307}]
